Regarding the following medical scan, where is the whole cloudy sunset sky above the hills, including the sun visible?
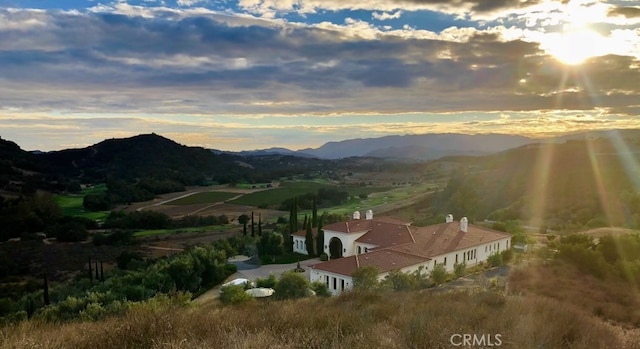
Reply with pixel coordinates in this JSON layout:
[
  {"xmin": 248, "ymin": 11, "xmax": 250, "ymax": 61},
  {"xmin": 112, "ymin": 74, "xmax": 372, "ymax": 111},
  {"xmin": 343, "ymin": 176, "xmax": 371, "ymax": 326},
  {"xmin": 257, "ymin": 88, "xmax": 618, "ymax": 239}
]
[{"xmin": 0, "ymin": 0, "xmax": 640, "ymax": 151}]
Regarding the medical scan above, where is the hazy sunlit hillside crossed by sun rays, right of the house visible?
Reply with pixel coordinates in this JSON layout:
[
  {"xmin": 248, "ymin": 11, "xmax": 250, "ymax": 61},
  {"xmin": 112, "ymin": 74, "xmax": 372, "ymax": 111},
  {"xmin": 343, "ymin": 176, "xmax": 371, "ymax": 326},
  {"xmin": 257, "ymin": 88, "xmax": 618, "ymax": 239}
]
[{"xmin": 429, "ymin": 138, "xmax": 640, "ymax": 228}]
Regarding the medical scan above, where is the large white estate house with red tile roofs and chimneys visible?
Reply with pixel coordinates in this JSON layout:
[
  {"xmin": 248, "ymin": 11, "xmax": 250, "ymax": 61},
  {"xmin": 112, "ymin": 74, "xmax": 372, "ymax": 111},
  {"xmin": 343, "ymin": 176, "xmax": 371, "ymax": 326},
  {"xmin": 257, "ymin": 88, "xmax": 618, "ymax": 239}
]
[{"xmin": 293, "ymin": 210, "xmax": 511, "ymax": 294}]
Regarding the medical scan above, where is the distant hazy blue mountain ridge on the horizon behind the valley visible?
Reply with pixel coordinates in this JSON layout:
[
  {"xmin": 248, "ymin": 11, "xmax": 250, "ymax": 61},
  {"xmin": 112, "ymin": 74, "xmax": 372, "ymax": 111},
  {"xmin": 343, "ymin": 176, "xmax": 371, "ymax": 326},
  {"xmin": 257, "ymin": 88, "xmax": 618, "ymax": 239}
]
[{"xmin": 298, "ymin": 133, "xmax": 536, "ymax": 160}]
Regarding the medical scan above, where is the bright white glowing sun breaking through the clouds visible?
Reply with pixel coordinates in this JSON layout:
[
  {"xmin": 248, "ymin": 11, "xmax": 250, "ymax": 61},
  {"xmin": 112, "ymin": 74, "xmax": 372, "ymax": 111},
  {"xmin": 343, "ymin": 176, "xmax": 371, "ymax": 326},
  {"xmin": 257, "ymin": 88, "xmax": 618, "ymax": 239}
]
[{"xmin": 541, "ymin": 28, "xmax": 603, "ymax": 65}]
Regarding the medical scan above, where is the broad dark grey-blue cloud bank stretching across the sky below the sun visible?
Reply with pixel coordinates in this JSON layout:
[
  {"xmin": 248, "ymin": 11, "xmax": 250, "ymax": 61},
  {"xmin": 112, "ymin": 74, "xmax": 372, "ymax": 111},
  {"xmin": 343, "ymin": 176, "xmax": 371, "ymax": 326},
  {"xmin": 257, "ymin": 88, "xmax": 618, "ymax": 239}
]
[{"xmin": 0, "ymin": 7, "xmax": 640, "ymax": 113}]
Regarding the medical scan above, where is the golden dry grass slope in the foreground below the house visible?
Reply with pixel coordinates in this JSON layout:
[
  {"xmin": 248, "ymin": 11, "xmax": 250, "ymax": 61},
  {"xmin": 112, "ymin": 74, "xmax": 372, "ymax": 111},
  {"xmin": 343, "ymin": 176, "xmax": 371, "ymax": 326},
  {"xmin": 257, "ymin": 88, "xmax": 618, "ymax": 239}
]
[{"xmin": 0, "ymin": 291, "xmax": 633, "ymax": 349}]
